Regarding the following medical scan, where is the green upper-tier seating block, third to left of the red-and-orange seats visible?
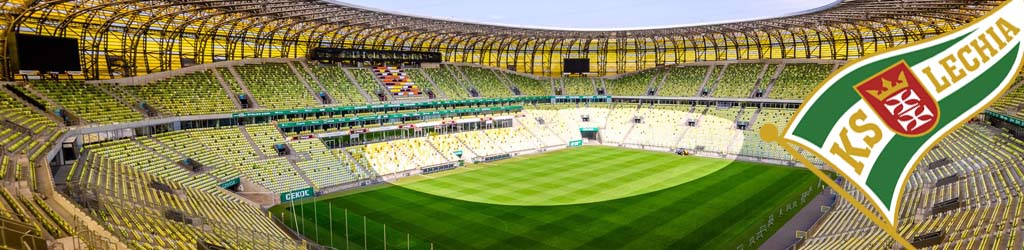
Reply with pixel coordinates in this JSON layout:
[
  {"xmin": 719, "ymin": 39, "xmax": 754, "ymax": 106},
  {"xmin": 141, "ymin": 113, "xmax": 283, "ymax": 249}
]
[{"xmin": 122, "ymin": 71, "xmax": 234, "ymax": 116}]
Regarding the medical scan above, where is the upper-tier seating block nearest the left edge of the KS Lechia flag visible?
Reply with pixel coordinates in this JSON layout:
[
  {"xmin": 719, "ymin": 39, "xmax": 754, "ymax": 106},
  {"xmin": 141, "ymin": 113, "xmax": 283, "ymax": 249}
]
[{"xmin": 768, "ymin": 64, "xmax": 835, "ymax": 99}]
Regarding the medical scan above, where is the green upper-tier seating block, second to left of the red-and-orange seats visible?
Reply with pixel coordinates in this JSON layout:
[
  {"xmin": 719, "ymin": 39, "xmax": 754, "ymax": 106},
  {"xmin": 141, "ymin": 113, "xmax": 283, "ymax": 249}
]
[{"xmin": 234, "ymin": 64, "xmax": 321, "ymax": 110}]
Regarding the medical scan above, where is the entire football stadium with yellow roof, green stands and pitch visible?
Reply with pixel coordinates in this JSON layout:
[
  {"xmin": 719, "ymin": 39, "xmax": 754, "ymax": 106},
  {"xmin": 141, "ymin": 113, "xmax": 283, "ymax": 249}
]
[{"xmin": 0, "ymin": 0, "xmax": 1024, "ymax": 250}]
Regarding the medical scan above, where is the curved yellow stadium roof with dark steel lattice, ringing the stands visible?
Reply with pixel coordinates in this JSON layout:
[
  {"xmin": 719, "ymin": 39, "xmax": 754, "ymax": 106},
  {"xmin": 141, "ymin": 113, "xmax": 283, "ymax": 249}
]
[{"xmin": 0, "ymin": 0, "xmax": 1002, "ymax": 78}]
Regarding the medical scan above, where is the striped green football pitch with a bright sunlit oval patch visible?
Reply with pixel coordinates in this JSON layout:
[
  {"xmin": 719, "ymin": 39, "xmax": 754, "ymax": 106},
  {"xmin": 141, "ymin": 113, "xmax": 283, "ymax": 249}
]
[{"xmin": 271, "ymin": 147, "xmax": 817, "ymax": 250}]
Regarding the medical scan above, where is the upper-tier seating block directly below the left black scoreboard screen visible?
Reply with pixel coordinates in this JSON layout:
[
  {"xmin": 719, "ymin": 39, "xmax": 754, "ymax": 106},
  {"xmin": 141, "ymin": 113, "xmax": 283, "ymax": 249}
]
[{"xmin": 32, "ymin": 82, "xmax": 142, "ymax": 123}]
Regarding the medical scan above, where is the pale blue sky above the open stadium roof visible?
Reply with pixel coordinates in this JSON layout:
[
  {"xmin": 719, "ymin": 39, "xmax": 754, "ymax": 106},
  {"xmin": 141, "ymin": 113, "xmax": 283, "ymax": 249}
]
[{"xmin": 333, "ymin": 0, "xmax": 836, "ymax": 29}]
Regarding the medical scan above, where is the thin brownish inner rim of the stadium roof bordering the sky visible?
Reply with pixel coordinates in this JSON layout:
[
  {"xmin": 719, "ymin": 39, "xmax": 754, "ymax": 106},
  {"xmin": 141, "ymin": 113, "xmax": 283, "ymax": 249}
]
[{"xmin": 157, "ymin": 0, "xmax": 999, "ymax": 39}]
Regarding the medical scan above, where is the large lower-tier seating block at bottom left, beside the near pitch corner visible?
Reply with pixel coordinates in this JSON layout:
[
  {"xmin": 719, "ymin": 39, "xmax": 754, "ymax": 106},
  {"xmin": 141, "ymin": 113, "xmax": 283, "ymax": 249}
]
[{"xmin": 73, "ymin": 154, "xmax": 300, "ymax": 249}]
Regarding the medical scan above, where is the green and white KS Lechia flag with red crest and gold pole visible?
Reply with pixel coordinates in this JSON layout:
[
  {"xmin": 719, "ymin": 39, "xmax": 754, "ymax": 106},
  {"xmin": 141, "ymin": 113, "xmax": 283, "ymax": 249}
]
[{"xmin": 761, "ymin": 0, "xmax": 1024, "ymax": 248}]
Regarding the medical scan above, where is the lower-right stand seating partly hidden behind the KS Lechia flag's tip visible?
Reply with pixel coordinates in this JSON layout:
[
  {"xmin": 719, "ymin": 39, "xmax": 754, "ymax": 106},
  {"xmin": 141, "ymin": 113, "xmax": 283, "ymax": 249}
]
[{"xmin": 804, "ymin": 124, "xmax": 1024, "ymax": 249}]
